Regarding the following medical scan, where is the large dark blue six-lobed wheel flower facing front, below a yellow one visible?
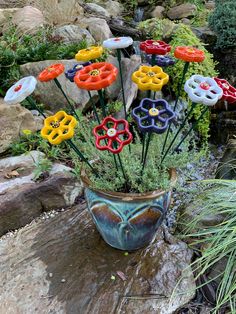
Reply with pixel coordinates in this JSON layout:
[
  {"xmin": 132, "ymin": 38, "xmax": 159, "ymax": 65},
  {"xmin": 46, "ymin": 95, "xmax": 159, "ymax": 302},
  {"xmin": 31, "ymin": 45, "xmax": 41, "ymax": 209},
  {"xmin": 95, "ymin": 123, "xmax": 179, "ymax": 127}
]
[{"xmin": 132, "ymin": 98, "xmax": 175, "ymax": 134}]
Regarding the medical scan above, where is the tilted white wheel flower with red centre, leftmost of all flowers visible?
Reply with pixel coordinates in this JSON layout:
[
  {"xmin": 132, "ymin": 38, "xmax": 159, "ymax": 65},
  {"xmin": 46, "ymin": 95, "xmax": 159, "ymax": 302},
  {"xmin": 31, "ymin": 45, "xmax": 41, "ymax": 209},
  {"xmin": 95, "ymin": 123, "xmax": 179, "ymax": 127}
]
[{"xmin": 4, "ymin": 76, "xmax": 37, "ymax": 105}]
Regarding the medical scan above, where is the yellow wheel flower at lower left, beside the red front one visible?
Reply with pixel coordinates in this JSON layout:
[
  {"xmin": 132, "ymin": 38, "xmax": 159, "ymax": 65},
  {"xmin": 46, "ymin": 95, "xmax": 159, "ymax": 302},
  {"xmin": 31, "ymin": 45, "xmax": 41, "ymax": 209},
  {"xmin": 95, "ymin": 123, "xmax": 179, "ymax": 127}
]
[{"xmin": 41, "ymin": 111, "xmax": 77, "ymax": 145}]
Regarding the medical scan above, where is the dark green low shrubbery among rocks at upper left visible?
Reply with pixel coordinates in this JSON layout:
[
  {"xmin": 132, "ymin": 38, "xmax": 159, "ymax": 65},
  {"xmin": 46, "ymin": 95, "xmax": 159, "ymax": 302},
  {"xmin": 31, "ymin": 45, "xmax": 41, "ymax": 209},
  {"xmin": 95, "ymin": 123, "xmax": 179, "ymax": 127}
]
[{"xmin": 0, "ymin": 26, "xmax": 87, "ymax": 91}]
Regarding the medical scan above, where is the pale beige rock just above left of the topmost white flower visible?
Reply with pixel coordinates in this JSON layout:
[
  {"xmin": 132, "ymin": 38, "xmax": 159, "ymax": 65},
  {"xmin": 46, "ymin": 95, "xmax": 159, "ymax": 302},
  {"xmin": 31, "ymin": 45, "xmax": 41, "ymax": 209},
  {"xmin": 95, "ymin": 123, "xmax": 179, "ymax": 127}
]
[{"xmin": 79, "ymin": 17, "xmax": 113, "ymax": 43}]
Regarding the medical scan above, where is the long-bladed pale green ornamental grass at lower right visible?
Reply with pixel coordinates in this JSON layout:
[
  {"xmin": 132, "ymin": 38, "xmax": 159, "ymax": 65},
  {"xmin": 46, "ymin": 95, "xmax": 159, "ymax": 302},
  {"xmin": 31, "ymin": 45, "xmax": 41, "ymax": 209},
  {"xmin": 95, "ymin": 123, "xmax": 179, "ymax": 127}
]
[{"xmin": 181, "ymin": 180, "xmax": 236, "ymax": 314}]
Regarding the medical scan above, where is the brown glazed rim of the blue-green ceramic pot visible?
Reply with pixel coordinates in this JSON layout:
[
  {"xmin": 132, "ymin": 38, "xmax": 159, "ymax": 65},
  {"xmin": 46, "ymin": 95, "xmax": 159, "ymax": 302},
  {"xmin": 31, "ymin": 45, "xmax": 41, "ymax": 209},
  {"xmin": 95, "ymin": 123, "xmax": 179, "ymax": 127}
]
[{"xmin": 81, "ymin": 168, "xmax": 177, "ymax": 202}]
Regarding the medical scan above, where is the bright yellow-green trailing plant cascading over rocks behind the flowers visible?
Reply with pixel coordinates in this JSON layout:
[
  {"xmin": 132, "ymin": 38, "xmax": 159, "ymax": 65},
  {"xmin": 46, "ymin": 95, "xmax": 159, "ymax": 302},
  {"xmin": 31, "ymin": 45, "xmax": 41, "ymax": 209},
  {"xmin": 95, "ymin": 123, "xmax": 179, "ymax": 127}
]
[{"xmin": 140, "ymin": 19, "xmax": 217, "ymax": 140}]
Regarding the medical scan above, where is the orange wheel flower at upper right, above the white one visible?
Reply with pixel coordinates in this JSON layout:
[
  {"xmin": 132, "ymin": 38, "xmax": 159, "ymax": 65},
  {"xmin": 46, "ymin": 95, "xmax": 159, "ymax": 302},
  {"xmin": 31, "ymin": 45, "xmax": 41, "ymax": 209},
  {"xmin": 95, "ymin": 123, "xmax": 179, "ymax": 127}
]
[{"xmin": 174, "ymin": 46, "xmax": 205, "ymax": 62}]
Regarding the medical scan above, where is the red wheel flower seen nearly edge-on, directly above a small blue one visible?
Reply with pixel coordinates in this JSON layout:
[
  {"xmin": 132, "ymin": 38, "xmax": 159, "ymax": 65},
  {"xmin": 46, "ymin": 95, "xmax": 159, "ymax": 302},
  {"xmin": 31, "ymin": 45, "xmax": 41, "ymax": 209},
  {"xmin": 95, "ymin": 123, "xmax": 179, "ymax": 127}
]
[{"xmin": 140, "ymin": 40, "xmax": 171, "ymax": 55}]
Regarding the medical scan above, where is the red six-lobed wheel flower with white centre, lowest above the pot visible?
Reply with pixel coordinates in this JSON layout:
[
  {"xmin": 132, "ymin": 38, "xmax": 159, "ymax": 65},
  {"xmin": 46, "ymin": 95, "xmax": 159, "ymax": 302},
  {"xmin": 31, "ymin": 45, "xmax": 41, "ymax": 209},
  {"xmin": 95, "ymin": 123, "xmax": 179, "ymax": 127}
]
[{"xmin": 93, "ymin": 117, "xmax": 133, "ymax": 154}]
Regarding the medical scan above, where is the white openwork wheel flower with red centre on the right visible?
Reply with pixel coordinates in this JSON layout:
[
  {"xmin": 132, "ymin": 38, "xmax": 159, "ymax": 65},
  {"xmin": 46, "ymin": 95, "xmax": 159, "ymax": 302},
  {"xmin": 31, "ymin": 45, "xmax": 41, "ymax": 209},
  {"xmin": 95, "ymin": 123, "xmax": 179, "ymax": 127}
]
[{"xmin": 184, "ymin": 75, "xmax": 223, "ymax": 106}]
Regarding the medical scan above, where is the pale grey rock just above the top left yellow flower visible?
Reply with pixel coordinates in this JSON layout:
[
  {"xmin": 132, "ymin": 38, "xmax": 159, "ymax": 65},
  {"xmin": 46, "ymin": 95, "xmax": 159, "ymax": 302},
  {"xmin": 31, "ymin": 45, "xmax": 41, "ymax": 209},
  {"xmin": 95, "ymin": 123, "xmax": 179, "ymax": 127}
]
[{"xmin": 53, "ymin": 25, "xmax": 95, "ymax": 45}]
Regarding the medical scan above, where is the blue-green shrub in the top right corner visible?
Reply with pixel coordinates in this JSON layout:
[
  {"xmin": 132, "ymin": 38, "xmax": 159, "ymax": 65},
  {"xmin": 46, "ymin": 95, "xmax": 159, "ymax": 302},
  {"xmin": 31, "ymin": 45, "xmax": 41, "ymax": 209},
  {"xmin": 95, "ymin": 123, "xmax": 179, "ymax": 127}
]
[{"xmin": 209, "ymin": 0, "xmax": 236, "ymax": 49}]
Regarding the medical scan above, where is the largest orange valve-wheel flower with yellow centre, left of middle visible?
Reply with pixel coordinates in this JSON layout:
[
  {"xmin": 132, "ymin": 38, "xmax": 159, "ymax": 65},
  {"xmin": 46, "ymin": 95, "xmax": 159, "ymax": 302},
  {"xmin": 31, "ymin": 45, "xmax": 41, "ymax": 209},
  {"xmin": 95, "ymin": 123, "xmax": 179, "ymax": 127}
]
[{"xmin": 74, "ymin": 62, "xmax": 118, "ymax": 90}]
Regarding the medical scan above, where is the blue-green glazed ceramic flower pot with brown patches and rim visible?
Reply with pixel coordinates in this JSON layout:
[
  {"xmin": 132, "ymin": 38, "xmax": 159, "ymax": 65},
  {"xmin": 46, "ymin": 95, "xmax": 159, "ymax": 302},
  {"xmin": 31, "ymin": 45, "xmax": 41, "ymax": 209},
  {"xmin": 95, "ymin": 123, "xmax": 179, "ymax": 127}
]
[{"xmin": 81, "ymin": 169, "xmax": 176, "ymax": 251}]
